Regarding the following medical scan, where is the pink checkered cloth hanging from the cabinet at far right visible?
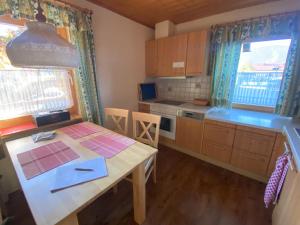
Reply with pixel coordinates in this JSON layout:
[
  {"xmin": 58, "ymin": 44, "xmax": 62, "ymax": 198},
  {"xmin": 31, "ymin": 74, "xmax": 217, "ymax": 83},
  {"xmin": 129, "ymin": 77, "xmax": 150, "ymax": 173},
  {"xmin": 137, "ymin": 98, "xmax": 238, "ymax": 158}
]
[{"xmin": 264, "ymin": 153, "xmax": 289, "ymax": 208}]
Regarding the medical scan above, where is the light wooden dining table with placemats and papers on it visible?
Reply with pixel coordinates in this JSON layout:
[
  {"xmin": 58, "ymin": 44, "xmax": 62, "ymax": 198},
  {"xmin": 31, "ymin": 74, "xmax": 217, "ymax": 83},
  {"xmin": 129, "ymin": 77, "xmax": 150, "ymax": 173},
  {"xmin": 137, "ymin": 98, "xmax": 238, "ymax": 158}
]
[{"xmin": 6, "ymin": 123, "xmax": 157, "ymax": 225}]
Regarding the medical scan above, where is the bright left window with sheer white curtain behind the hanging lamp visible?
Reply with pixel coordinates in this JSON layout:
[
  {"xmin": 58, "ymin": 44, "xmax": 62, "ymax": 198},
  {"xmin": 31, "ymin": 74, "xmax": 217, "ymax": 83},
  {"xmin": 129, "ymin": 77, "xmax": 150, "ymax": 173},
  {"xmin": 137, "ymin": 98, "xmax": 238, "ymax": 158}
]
[{"xmin": 0, "ymin": 23, "xmax": 73, "ymax": 120}]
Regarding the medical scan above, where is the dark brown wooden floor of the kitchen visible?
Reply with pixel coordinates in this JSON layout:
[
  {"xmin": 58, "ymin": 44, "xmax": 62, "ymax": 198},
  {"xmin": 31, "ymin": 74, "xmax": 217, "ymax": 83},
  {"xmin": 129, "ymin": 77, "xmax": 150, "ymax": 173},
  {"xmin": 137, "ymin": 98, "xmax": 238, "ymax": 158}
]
[{"xmin": 7, "ymin": 146, "xmax": 272, "ymax": 225}]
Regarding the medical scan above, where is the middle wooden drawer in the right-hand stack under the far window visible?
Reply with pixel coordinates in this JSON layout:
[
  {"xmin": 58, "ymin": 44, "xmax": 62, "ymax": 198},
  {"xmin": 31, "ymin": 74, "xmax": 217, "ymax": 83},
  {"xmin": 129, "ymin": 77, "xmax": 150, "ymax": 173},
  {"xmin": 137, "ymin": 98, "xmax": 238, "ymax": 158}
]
[{"xmin": 234, "ymin": 130, "xmax": 275, "ymax": 157}]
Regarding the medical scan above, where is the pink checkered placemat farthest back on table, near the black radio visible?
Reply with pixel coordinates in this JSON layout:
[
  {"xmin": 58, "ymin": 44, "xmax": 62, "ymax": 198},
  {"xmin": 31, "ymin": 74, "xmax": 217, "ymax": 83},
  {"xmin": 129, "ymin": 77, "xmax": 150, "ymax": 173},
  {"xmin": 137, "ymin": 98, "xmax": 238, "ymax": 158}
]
[{"xmin": 59, "ymin": 122, "xmax": 105, "ymax": 139}]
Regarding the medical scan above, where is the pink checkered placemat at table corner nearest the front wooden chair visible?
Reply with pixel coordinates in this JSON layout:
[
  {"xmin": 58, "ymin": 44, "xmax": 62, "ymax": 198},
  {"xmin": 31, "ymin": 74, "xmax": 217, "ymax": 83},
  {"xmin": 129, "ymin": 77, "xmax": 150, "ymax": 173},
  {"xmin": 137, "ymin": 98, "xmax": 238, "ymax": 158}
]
[{"xmin": 80, "ymin": 132, "xmax": 135, "ymax": 158}]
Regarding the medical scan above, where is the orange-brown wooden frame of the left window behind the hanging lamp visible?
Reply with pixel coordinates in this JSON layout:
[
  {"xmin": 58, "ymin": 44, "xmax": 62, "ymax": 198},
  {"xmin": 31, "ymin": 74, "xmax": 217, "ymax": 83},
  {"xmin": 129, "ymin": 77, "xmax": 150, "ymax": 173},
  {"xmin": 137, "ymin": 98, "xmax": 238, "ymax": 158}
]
[{"xmin": 0, "ymin": 15, "xmax": 80, "ymax": 129}]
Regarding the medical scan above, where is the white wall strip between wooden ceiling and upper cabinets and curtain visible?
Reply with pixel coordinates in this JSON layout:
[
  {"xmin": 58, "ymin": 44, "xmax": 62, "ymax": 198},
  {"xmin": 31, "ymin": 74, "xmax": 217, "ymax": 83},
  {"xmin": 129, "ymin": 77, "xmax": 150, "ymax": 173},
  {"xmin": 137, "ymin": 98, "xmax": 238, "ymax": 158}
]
[{"xmin": 176, "ymin": 0, "xmax": 300, "ymax": 33}]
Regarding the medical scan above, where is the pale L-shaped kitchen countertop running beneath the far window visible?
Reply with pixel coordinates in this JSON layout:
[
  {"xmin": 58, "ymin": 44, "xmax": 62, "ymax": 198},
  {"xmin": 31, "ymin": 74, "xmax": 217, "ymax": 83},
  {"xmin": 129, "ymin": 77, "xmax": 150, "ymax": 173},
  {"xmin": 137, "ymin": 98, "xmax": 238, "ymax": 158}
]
[{"xmin": 140, "ymin": 101, "xmax": 300, "ymax": 171}]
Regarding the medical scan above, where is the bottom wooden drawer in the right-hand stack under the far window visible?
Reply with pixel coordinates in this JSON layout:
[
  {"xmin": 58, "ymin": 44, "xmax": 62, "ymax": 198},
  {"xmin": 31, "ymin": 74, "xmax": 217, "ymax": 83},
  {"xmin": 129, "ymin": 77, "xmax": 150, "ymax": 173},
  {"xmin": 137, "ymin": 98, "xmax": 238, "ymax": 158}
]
[{"xmin": 231, "ymin": 149, "xmax": 269, "ymax": 176}]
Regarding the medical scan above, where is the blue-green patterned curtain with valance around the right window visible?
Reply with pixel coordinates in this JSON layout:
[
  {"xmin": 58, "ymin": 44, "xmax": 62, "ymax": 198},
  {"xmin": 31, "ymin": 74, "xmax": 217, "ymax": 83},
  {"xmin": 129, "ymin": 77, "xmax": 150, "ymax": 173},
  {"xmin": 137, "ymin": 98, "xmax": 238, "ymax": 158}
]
[{"xmin": 209, "ymin": 12, "xmax": 300, "ymax": 115}]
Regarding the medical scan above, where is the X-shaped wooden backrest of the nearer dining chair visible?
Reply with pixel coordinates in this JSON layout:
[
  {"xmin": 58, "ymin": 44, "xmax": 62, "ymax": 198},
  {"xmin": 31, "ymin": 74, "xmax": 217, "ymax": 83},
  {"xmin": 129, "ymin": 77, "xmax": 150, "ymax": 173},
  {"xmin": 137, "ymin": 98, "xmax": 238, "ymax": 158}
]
[{"xmin": 132, "ymin": 112, "xmax": 161, "ymax": 148}]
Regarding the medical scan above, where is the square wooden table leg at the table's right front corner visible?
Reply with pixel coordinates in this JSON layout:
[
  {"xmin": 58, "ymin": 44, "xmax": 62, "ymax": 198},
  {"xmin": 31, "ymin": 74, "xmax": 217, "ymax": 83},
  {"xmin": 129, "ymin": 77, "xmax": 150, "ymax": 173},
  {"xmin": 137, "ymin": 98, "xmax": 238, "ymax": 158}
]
[{"xmin": 132, "ymin": 163, "xmax": 146, "ymax": 224}]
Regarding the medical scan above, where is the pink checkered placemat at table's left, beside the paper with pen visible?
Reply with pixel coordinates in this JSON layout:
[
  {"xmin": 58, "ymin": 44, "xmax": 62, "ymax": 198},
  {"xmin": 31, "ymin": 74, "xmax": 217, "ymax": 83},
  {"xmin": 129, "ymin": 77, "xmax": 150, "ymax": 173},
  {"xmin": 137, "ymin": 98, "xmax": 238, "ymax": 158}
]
[{"xmin": 17, "ymin": 141, "xmax": 79, "ymax": 180}]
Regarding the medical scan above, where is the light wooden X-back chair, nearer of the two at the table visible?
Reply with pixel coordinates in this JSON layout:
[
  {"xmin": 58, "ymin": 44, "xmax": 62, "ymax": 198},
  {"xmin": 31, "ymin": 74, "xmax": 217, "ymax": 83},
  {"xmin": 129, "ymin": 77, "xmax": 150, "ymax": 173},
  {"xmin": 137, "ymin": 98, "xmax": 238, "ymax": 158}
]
[{"xmin": 132, "ymin": 112, "xmax": 161, "ymax": 183}]
